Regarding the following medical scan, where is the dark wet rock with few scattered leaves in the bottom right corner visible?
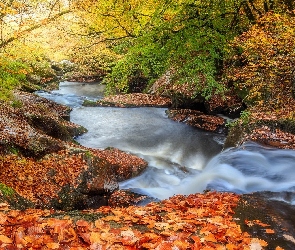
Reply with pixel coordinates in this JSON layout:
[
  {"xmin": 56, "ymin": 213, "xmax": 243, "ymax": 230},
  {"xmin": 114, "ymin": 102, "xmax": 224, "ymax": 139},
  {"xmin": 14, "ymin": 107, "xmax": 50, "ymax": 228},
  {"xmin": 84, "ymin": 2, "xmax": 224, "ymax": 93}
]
[{"xmin": 234, "ymin": 192, "xmax": 295, "ymax": 249}]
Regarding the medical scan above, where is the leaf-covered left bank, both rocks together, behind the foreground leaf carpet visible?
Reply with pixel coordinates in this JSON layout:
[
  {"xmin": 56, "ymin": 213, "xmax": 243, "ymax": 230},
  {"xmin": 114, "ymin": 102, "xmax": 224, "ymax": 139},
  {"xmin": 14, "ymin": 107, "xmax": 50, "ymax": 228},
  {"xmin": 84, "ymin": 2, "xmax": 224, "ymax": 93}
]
[{"xmin": 0, "ymin": 92, "xmax": 147, "ymax": 210}]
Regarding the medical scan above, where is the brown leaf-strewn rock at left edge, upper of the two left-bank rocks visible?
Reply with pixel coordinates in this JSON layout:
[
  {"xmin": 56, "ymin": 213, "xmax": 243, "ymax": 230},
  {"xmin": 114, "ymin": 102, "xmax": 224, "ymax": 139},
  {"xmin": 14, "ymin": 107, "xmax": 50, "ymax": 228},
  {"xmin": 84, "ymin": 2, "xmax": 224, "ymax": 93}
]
[{"xmin": 0, "ymin": 92, "xmax": 86, "ymax": 158}]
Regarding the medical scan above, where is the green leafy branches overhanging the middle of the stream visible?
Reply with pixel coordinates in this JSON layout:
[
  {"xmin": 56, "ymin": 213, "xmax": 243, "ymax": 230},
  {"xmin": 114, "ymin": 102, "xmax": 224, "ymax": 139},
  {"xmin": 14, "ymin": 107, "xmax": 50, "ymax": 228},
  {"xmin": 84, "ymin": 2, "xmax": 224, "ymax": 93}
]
[{"xmin": 106, "ymin": 1, "xmax": 237, "ymax": 97}]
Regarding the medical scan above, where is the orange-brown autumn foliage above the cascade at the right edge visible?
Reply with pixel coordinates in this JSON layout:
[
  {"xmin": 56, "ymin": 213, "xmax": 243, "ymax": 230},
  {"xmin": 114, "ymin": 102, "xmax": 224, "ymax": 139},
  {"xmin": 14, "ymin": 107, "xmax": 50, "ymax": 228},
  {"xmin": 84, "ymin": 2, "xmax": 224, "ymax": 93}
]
[{"xmin": 226, "ymin": 12, "xmax": 295, "ymax": 108}]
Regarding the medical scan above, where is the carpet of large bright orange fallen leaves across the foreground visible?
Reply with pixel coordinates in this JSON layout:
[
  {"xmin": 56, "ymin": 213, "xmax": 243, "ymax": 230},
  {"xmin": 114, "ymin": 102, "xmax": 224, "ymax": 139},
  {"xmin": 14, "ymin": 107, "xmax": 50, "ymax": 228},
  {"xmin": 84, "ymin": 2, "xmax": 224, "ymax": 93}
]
[{"xmin": 0, "ymin": 192, "xmax": 279, "ymax": 250}]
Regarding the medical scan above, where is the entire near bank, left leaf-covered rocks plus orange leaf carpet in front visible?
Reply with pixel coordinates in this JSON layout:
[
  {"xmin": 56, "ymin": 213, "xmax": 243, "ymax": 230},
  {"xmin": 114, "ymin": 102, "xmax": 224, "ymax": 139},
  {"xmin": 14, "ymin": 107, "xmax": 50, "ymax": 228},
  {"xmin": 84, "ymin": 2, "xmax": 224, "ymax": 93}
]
[{"xmin": 0, "ymin": 87, "xmax": 294, "ymax": 249}]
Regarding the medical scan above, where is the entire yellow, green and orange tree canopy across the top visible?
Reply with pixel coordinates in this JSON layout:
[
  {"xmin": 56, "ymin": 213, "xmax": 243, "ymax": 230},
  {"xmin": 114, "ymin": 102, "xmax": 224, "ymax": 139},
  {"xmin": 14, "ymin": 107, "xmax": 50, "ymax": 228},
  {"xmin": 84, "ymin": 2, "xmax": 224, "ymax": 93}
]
[{"xmin": 0, "ymin": 0, "xmax": 294, "ymax": 104}]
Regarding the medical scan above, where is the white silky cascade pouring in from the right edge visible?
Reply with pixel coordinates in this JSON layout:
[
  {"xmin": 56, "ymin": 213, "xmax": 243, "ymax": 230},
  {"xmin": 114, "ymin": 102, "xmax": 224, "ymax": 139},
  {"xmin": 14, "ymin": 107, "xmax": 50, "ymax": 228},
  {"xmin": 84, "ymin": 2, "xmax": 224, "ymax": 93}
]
[{"xmin": 121, "ymin": 142, "xmax": 295, "ymax": 199}]
